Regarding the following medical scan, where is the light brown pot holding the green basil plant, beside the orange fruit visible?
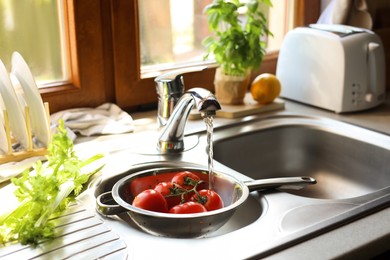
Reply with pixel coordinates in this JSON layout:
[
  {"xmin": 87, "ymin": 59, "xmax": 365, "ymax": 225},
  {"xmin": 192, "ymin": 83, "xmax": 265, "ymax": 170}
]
[{"xmin": 214, "ymin": 68, "xmax": 250, "ymax": 105}]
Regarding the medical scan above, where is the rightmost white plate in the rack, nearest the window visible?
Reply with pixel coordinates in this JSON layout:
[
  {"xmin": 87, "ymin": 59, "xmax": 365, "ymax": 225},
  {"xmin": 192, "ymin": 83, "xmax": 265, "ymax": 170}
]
[{"xmin": 11, "ymin": 52, "xmax": 50, "ymax": 146}]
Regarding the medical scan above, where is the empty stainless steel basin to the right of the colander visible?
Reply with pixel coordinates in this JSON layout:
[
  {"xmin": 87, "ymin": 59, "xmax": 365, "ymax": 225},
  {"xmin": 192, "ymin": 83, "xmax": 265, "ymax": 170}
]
[{"xmin": 214, "ymin": 116, "xmax": 390, "ymax": 199}]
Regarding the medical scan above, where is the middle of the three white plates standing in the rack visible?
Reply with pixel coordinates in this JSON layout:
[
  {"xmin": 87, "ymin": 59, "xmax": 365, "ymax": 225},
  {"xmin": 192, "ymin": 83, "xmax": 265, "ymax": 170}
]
[{"xmin": 0, "ymin": 60, "xmax": 29, "ymax": 148}]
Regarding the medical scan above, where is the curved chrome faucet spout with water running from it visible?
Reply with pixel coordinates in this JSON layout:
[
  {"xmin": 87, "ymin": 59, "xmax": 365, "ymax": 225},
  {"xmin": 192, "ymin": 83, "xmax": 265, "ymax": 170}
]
[{"xmin": 158, "ymin": 88, "xmax": 221, "ymax": 153}]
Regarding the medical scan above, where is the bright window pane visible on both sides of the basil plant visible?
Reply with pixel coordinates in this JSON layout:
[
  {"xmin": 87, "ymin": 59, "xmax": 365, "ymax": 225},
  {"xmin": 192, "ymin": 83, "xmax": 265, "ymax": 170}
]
[{"xmin": 138, "ymin": 0, "xmax": 294, "ymax": 74}]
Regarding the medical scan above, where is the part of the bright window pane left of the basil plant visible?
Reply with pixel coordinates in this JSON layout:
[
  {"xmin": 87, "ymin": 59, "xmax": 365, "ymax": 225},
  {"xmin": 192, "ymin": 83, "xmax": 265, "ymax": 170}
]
[{"xmin": 138, "ymin": 0, "xmax": 210, "ymax": 70}]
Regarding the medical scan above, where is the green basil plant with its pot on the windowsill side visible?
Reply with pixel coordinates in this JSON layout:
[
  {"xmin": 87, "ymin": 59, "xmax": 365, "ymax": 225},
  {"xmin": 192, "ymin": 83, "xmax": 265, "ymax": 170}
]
[{"xmin": 203, "ymin": 0, "xmax": 271, "ymax": 105}]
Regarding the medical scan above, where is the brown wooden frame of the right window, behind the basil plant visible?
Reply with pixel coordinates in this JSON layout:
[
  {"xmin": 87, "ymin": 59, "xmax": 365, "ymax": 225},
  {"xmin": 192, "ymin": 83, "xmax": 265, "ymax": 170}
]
[{"xmin": 112, "ymin": 0, "xmax": 320, "ymax": 110}]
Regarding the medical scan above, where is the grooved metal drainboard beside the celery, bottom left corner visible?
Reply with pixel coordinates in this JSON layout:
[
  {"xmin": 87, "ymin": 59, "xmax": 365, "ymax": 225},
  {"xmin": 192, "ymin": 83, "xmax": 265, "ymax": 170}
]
[{"xmin": 0, "ymin": 203, "xmax": 127, "ymax": 259}]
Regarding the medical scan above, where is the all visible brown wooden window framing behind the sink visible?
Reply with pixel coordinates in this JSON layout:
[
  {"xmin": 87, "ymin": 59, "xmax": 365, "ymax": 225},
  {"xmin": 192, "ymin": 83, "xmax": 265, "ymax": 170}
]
[{"xmin": 41, "ymin": 0, "xmax": 320, "ymax": 112}]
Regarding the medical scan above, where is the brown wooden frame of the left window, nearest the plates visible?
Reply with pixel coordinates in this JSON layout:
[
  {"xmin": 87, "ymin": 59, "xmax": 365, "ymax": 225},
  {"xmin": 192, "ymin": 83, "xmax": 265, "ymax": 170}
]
[{"xmin": 40, "ymin": 0, "xmax": 115, "ymax": 113}]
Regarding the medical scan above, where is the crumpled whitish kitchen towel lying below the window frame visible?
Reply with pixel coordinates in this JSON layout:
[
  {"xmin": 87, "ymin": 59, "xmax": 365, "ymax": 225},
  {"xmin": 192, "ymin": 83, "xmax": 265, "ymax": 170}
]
[{"xmin": 50, "ymin": 103, "xmax": 134, "ymax": 136}]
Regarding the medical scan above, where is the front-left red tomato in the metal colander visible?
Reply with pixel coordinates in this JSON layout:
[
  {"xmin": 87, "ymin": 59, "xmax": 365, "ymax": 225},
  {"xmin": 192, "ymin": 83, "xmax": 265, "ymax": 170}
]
[{"xmin": 133, "ymin": 189, "xmax": 168, "ymax": 213}]
